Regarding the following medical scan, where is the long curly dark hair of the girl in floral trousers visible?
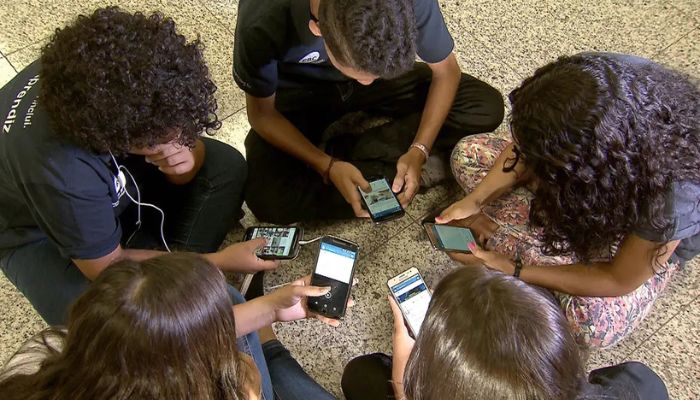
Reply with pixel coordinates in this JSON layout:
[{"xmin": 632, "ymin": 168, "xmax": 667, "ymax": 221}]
[{"xmin": 510, "ymin": 54, "xmax": 700, "ymax": 262}]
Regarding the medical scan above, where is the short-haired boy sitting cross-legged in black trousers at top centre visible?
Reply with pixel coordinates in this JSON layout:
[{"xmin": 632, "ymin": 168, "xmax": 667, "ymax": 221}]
[{"xmin": 233, "ymin": 0, "xmax": 503, "ymax": 223}]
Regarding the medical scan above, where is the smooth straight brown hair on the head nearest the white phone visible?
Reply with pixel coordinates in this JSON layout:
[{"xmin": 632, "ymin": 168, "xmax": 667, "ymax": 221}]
[{"xmin": 403, "ymin": 267, "xmax": 583, "ymax": 400}]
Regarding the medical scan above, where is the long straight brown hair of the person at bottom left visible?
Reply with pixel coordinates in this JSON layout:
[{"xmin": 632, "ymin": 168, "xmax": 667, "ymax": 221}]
[{"xmin": 0, "ymin": 253, "xmax": 254, "ymax": 400}]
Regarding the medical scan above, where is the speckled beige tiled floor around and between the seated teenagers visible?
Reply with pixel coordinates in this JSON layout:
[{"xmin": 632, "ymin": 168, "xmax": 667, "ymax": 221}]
[{"xmin": 0, "ymin": 0, "xmax": 700, "ymax": 399}]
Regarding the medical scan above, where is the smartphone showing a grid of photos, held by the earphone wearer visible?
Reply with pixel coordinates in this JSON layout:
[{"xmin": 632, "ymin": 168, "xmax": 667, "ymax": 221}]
[{"xmin": 243, "ymin": 226, "xmax": 304, "ymax": 260}]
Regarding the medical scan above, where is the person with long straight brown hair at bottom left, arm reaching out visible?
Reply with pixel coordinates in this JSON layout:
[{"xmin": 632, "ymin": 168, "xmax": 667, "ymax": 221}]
[{"xmin": 0, "ymin": 253, "xmax": 340, "ymax": 400}]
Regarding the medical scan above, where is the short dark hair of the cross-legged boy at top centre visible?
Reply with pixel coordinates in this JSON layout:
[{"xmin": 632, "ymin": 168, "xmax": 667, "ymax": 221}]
[{"xmin": 319, "ymin": 0, "xmax": 416, "ymax": 79}]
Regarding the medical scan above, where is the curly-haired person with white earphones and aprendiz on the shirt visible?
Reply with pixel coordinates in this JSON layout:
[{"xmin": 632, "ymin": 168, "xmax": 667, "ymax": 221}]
[{"xmin": 0, "ymin": 7, "xmax": 276, "ymax": 325}]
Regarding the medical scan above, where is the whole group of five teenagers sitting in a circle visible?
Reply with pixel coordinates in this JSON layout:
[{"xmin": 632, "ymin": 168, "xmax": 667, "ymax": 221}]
[{"xmin": 0, "ymin": 0, "xmax": 700, "ymax": 400}]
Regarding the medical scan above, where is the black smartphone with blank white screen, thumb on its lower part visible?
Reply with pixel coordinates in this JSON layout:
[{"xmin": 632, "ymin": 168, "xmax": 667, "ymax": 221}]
[{"xmin": 307, "ymin": 236, "xmax": 360, "ymax": 319}]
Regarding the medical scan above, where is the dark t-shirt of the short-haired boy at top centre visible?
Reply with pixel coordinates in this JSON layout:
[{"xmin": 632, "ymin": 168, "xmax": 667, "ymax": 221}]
[{"xmin": 233, "ymin": 0, "xmax": 454, "ymax": 97}]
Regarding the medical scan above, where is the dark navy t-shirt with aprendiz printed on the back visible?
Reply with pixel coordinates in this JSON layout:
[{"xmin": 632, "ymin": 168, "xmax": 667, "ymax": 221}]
[{"xmin": 0, "ymin": 61, "xmax": 129, "ymax": 259}]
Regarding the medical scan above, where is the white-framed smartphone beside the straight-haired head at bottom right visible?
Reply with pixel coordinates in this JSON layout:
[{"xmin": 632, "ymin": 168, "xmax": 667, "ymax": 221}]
[{"xmin": 387, "ymin": 268, "xmax": 431, "ymax": 338}]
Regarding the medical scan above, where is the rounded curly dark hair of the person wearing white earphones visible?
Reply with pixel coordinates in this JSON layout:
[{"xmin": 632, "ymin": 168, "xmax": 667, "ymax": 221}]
[{"xmin": 40, "ymin": 7, "xmax": 221, "ymax": 154}]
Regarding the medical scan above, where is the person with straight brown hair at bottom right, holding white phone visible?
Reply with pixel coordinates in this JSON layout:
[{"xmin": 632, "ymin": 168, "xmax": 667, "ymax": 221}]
[{"xmin": 342, "ymin": 266, "xmax": 668, "ymax": 400}]
